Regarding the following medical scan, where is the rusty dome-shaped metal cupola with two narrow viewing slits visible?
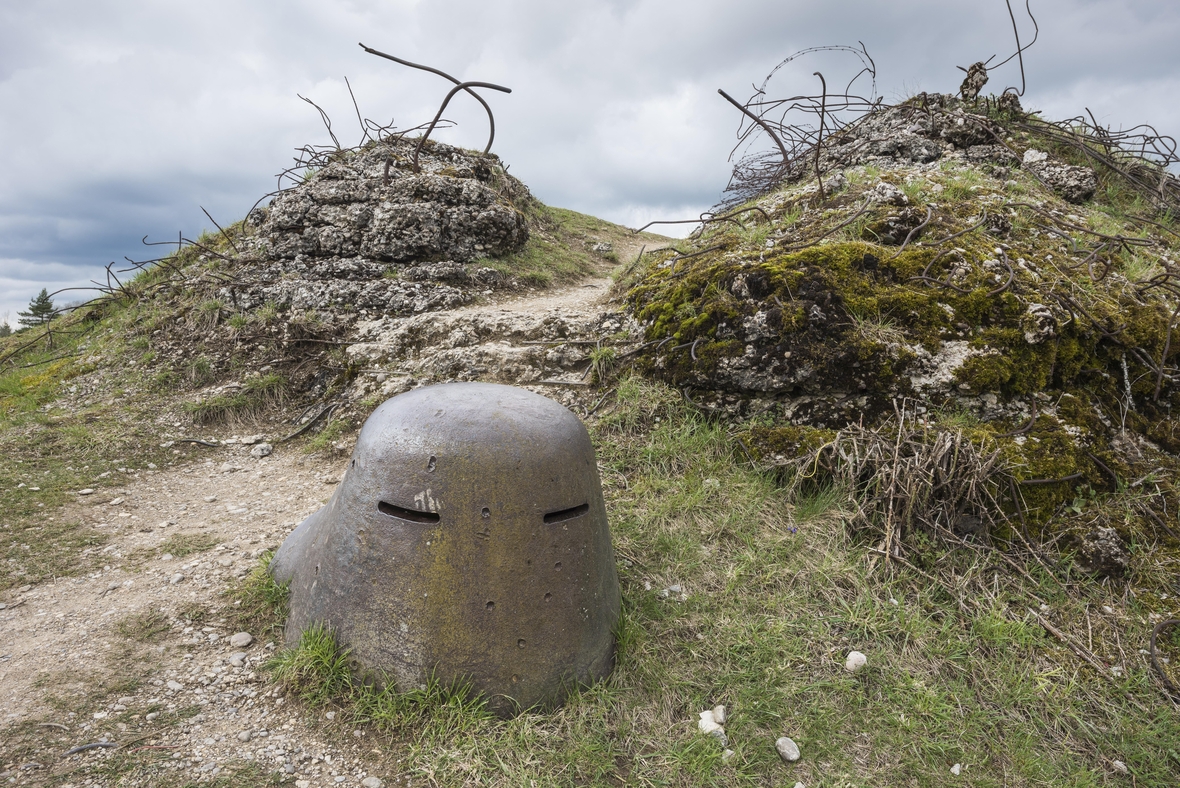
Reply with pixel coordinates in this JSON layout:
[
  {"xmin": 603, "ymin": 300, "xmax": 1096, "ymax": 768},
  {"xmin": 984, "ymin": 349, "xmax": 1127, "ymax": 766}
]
[{"xmin": 271, "ymin": 383, "xmax": 620, "ymax": 714}]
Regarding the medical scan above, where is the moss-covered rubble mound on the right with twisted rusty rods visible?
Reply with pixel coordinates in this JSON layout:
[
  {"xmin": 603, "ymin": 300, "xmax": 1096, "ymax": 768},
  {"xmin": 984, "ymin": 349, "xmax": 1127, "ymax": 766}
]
[{"xmin": 625, "ymin": 94, "xmax": 1180, "ymax": 536}]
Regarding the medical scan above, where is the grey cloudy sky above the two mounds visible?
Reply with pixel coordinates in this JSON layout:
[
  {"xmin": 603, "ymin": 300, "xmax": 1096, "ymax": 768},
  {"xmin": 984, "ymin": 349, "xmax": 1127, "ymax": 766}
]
[{"xmin": 0, "ymin": 0, "xmax": 1180, "ymax": 323}]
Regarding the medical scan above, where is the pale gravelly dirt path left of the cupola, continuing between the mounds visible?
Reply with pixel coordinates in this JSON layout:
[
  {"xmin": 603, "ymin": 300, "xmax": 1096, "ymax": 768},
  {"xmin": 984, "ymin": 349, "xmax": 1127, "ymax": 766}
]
[{"xmin": 0, "ymin": 261, "xmax": 637, "ymax": 788}]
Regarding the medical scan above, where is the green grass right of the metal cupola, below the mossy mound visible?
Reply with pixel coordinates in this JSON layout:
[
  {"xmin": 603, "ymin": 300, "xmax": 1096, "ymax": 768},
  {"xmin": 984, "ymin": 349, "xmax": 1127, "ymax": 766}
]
[{"xmin": 246, "ymin": 377, "xmax": 1180, "ymax": 787}]
